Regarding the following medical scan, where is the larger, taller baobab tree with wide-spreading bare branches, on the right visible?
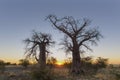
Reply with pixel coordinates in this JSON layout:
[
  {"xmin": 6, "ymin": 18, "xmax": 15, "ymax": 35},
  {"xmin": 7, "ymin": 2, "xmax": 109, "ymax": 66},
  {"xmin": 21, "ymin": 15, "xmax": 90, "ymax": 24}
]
[{"xmin": 47, "ymin": 15, "xmax": 102, "ymax": 73}]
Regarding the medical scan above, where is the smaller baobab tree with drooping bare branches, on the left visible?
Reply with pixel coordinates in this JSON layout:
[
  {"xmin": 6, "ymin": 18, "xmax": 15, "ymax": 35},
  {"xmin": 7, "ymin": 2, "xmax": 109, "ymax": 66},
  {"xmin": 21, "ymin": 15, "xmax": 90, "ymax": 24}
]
[{"xmin": 24, "ymin": 31, "xmax": 54, "ymax": 68}]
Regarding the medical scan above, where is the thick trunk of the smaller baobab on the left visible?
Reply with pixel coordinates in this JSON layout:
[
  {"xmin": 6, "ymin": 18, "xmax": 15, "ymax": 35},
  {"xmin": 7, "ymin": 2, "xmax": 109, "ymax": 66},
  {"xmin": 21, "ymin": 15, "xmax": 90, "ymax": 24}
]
[{"xmin": 39, "ymin": 44, "xmax": 46, "ymax": 69}]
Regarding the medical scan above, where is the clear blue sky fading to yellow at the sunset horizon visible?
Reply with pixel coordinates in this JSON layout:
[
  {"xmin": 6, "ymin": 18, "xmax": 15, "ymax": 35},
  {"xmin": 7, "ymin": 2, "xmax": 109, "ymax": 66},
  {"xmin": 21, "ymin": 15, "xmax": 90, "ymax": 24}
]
[{"xmin": 0, "ymin": 0, "xmax": 120, "ymax": 64}]
